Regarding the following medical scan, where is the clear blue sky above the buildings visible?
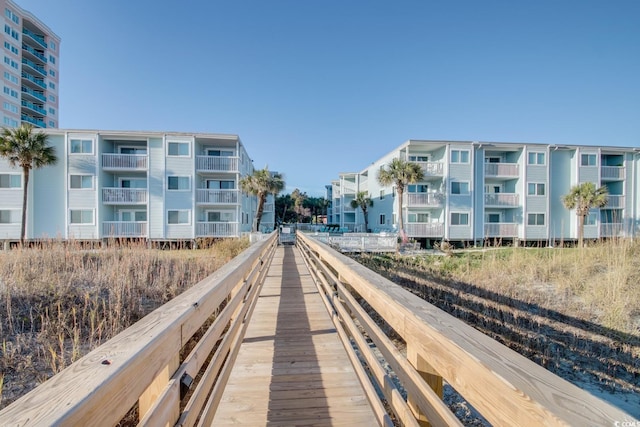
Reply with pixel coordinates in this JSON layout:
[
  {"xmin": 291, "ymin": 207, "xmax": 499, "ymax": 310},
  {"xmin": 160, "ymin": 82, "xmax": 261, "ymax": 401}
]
[{"xmin": 15, "ymin": 0, "xmax": 640, "ymax": 196}]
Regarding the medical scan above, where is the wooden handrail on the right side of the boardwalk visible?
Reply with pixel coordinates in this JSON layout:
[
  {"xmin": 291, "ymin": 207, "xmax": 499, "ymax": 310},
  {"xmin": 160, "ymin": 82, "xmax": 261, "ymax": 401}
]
[{"xmin": 297, "ymin": 232, "xmax": 630, "ymax": 425}]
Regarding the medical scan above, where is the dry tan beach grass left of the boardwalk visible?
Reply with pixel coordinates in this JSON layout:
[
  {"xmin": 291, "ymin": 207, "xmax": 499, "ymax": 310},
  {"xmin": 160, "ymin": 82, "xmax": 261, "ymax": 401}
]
[{"xmin": 0, "ymin": 239, "xmax": 249, "ymax": 408}]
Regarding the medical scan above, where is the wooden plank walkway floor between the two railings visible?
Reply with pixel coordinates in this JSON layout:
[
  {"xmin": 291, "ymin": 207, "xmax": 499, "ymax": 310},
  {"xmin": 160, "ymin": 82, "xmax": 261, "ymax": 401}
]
[{"xmin": 213, "ymin": 246, "xmax": 378, "ymax": 426}]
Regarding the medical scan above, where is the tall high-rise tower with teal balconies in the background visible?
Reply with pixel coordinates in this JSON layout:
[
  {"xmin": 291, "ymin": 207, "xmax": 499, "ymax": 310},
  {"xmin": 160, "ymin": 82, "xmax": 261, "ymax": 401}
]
[{"xmin": 0, "ymin": 0, "xmax": 60, "ymax": 128}]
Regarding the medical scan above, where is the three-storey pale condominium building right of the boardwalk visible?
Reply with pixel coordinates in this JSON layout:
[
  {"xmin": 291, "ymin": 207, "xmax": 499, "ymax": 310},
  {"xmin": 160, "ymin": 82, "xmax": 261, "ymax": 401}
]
[{"xmin": 327, "ymin": 140, "xmax": 640, "ymax": 245}]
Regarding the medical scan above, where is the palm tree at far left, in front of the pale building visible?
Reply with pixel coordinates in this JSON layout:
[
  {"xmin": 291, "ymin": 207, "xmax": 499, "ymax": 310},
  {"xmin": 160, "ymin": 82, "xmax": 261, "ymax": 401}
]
[{"xmin": 0, "ymin": 123, "xmax": 58, "ymax": 244}]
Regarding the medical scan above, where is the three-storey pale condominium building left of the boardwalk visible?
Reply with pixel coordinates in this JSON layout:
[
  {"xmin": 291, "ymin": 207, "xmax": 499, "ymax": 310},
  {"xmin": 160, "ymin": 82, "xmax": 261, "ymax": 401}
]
[{"xmin": 0, "ymin": 129, "xmax": 275, "ymax": 241}]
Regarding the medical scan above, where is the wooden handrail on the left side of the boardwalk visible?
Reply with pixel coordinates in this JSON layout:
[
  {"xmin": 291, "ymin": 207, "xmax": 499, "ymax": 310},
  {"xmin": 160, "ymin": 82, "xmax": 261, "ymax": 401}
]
[{"xmin": 0, "ymin": 233, "xmax": 277, "ymax": 426}]
